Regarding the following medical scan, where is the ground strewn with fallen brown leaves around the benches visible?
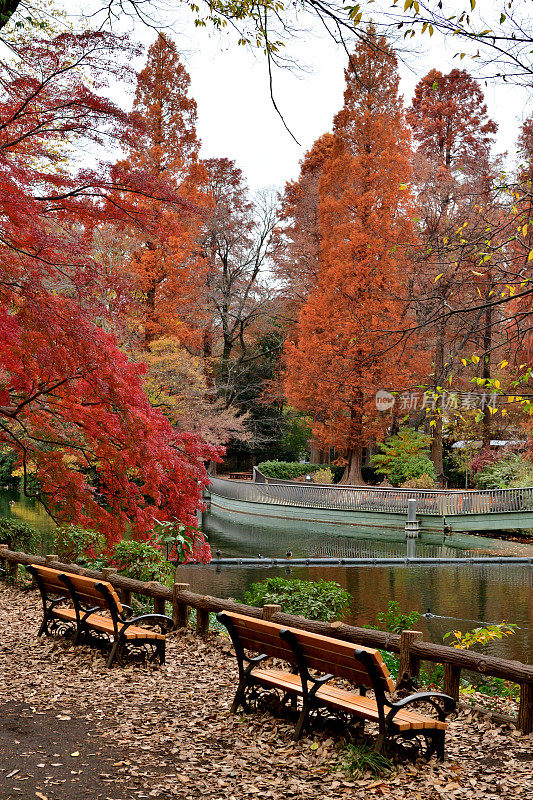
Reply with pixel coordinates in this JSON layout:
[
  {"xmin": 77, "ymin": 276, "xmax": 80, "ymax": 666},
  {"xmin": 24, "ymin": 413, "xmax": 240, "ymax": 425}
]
[{"xmin": 0, "ymin": 587, "xmax": 533, "ymax": 800}]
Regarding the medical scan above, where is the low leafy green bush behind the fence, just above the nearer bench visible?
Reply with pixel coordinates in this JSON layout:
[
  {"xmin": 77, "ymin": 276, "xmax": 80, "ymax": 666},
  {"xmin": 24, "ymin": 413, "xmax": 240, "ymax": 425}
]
[{"xmin": 244, "ymin": 578, "xmax": 351, "ymax": 622}]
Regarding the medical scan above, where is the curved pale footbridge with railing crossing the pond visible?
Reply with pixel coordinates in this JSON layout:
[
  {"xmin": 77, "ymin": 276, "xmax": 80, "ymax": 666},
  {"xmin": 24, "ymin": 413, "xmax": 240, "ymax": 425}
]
[{"xmin": 205, "ymin": 476, "xmax": 533, "ymax": 537}]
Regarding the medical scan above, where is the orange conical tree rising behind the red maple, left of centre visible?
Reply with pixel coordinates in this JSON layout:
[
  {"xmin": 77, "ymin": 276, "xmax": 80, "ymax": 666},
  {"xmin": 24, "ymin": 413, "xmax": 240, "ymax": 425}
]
[{"xmin": 120, "ymin": 34, "xmax": 207, "ymax": 349}]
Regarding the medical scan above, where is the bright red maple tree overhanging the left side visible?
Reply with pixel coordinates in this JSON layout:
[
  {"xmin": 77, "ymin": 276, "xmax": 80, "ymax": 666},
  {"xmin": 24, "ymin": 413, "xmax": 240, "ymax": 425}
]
[{"xmin": 0, "ymin": 33, "xmax": 215, "ymax": 542}]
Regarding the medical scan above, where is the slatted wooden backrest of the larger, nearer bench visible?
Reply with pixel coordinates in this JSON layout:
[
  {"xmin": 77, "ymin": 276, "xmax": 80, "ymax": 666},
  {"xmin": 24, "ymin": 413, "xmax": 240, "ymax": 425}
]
[{"xmin": 224, "ymin": 612, "xmax": 394, "ymax": 692}]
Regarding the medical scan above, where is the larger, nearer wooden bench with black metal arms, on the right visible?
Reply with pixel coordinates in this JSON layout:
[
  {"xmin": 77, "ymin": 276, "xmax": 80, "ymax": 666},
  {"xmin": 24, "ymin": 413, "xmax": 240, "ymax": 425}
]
[{"xmin": 217, "ymin": 612, "xmax": 456, "ymax": 760}]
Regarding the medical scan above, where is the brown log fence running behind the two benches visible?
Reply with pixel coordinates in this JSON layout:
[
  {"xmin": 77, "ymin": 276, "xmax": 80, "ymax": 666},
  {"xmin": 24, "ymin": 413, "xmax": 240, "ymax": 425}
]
[{"xmin": 0, "ymin": 544, "xmax": 533, "ymax": 733}]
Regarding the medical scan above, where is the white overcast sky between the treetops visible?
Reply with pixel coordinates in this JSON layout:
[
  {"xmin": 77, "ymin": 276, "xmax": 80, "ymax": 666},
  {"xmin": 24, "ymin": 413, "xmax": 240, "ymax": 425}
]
[{"xmin": 74, "ymin": 0, "xmax": 533, "ymax": 190}]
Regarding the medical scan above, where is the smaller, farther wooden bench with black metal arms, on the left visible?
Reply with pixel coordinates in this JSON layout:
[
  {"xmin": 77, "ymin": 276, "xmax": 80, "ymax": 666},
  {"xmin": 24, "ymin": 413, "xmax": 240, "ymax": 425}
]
[{"xmin": 27, "ymin": 564, "xmax": 173, "ymax": 667}]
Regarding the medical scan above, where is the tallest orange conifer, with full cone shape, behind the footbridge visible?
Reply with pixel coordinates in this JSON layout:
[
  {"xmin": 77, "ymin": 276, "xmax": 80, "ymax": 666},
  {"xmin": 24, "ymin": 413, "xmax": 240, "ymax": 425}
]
[{"xmin": 285, "ymin": 30, "xmax": 424, "ymax": 484}]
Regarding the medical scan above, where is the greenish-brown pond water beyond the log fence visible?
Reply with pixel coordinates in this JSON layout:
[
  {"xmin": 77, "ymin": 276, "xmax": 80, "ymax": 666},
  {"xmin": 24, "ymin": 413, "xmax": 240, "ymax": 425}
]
[{"xmin": 0, "ymin": 492, "xmax": 533, "ymax": 664}]
